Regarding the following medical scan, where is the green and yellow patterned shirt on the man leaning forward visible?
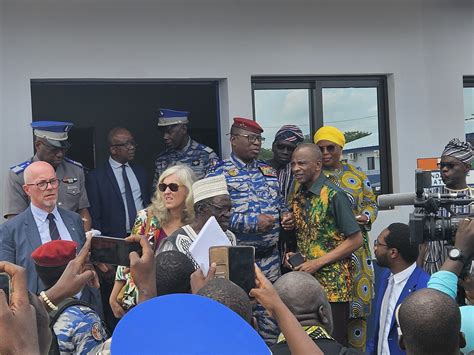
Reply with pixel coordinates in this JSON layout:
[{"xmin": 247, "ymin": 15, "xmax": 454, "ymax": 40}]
[{"xmin": 291, "ymin": 174, "xmax": 360, "ymax": 302}]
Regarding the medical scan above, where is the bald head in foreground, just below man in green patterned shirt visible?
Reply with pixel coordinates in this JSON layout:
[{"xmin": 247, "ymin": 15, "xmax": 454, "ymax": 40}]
[{"xmin": 274, "ymin": 271, "xmax": 333, "ymax": 333}]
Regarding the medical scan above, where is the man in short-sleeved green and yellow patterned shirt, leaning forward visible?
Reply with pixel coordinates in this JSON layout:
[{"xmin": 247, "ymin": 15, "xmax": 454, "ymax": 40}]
[{"xmin": 286, "ymin": 143, "xmax": 363, "ymax": 345}]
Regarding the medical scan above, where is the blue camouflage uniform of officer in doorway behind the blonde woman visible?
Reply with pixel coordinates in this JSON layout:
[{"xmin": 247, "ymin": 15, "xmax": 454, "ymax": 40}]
[{"xmin": 153, "ymin": 138, "xmax": 219, "ymax": 190}]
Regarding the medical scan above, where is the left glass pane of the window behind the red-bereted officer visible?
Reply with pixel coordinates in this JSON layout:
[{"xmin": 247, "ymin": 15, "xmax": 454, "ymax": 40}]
[{"xmin": 254, "ymin": 89, "xmax": 310, "ymax": 160}]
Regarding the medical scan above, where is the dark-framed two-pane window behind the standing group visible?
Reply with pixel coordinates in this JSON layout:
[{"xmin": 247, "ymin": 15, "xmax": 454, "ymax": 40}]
[{"xmin": 252, "ymin": 76, "xmax": 390, "ymax": 193}]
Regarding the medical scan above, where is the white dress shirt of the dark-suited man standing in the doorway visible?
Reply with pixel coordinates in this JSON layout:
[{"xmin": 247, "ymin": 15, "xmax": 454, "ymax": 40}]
[{"xmin": 109, "ymin": 157, "xmax": 144, "ymax": 233}]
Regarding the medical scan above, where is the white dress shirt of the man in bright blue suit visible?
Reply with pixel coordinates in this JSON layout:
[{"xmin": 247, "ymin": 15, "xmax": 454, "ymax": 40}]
[{"xmin": 377, "ymin": 263, "xmax": 416, "ymax": 355}]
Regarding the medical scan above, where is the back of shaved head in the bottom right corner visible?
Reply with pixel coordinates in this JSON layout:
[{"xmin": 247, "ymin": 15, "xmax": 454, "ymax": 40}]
[{"xmin": 398, "ymin": 288, "xmax": 464, "ymax": 355}]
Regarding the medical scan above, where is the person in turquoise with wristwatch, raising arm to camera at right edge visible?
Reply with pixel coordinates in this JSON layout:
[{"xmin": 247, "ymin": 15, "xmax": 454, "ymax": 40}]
[{"xmin": 428, "ymin": 218, "xmax": 474, "ymax": 354}]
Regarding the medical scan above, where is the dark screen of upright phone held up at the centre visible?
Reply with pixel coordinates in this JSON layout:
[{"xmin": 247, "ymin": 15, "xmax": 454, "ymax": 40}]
[{"xmin": 229, "ymin": 246, "xmax": 255, "ymax": 293}]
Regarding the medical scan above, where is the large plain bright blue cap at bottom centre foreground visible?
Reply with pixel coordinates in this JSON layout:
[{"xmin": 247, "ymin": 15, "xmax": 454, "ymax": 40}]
[{"xmin": 111, "ymin": 294, "xmax": 271, "ymax": 355}]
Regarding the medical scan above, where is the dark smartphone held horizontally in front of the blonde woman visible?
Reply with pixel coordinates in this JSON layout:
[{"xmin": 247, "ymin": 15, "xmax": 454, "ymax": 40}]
[{"xmin": 91, "ymin": 236, "xmax": 142, "ymax": 266}]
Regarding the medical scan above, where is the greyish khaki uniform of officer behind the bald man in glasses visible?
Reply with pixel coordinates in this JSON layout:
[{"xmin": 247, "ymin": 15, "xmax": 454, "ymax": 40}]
[{"xmin": 3, "ymin": 155, "xmax": 89, "ymax": 217}]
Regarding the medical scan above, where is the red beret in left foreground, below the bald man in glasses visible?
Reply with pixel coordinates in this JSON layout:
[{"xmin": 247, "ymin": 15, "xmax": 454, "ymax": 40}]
[{"xmin": 31, "ymin": 240, "xmax": 77, "ymax": 267}]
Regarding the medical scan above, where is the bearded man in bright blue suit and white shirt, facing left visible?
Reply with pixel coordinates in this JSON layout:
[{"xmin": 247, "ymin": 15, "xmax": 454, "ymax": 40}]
[{"xmin": 367, "ymin": 223, "xmax": 430, "ymax": 355}]
